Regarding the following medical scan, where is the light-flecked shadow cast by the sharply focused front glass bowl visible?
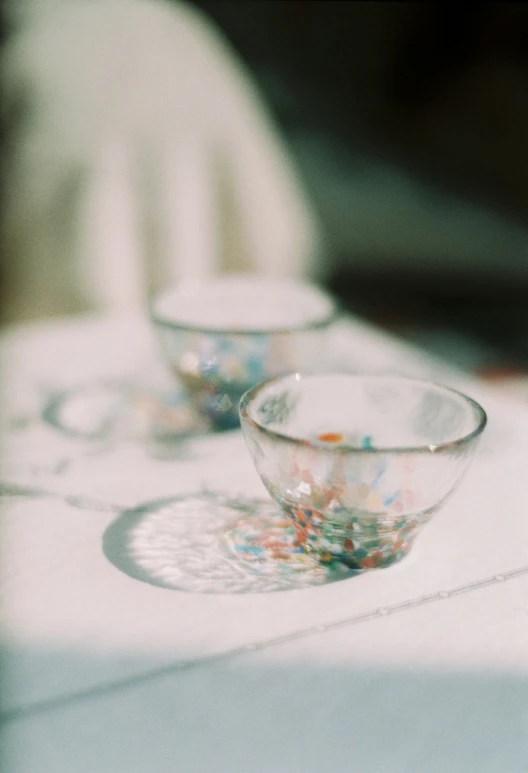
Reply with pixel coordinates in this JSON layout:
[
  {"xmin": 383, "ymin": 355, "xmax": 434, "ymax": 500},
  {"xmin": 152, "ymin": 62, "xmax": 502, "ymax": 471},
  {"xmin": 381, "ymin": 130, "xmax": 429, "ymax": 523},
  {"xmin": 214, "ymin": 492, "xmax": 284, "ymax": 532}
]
[{"xmin": 103, "ymin": 493, "xmax": 356, "ymax": 593}]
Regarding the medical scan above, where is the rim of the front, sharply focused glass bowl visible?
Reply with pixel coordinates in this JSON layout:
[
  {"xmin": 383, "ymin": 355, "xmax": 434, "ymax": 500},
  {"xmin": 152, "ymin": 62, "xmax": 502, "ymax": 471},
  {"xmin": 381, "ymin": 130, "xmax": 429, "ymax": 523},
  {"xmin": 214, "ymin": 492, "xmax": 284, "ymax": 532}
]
[{"xmin": 238, "ymin": 371, "xmax": 488, "ymax": 454}]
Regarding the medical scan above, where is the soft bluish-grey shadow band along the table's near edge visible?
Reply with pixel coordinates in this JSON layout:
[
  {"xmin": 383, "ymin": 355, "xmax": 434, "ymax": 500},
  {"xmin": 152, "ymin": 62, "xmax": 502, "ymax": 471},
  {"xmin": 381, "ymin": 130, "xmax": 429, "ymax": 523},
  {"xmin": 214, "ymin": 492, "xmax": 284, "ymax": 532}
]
[{"xmin": 2, "ymin": 644, "xmax": 528, "ymax": 773}]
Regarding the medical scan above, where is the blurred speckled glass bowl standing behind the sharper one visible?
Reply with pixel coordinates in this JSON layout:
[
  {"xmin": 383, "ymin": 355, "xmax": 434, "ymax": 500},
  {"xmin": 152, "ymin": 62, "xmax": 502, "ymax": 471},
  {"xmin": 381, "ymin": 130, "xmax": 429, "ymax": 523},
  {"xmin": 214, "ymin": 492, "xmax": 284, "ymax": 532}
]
[{"xmin": 150, "ymin": 274, "xmax": 336, "ymax": 429}]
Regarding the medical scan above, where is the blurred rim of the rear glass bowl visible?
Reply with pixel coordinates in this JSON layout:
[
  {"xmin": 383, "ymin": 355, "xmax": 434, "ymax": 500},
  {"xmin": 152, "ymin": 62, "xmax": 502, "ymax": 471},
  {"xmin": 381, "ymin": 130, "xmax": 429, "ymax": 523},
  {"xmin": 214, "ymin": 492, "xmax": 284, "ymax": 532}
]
[{"xmin": 148, "ymin": 274, "xmax": 342, "ymax": 336}]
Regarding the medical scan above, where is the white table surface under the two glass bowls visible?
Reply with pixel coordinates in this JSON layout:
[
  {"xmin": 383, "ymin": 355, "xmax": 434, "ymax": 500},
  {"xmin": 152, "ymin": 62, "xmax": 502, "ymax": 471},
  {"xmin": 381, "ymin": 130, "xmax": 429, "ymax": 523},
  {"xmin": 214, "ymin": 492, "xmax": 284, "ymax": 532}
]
[{"xmin": 0, "ymin": 310, "xmax": 528, "ymax": 773}]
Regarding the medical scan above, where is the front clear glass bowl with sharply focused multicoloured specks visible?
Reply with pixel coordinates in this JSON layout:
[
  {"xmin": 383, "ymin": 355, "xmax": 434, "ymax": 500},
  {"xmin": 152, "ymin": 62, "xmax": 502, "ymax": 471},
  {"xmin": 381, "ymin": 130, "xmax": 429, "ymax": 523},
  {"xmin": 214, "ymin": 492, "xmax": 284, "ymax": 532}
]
[{"xmin": 240, "ymin": 374, "xmax": 486, "ymax": 570}]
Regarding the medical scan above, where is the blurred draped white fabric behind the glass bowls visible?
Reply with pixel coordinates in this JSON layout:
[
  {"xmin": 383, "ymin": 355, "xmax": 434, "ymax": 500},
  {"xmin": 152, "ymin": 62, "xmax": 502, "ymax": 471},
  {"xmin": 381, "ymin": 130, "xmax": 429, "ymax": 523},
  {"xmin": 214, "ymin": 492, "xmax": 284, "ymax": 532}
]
[{"xmin": 2, "ymin": 0, "xmax": 321, "ymax": 319}]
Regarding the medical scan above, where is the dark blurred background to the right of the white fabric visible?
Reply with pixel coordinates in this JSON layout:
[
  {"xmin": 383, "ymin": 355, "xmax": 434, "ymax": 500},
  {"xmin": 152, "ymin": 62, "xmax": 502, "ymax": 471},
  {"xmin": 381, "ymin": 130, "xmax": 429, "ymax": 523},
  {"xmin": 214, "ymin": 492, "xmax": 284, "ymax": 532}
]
[{"xmin": 186, "ymin": 0, "xmax": 528, "ymax": 370}]
